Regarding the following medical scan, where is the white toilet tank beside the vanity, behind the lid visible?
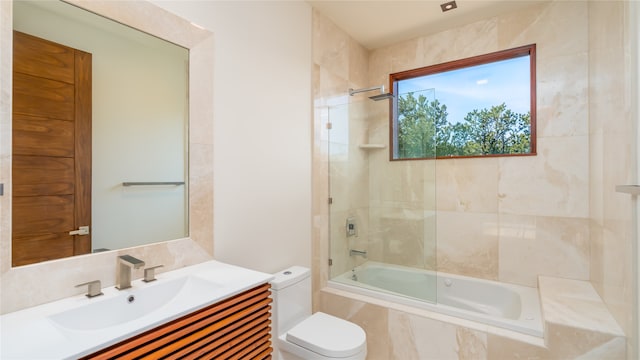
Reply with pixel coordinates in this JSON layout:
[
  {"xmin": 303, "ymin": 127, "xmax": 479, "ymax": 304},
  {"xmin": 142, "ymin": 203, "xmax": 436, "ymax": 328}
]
[{"xmin": 271, "ymin": 266, "xmax": 311, "ymax": 336}]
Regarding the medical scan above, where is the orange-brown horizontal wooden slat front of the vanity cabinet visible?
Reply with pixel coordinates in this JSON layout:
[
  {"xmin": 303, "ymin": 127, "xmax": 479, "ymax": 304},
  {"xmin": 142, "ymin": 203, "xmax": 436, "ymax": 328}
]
[{"xmin": 82, "ymin": 284, "xmax": 273, "ymax": 359}]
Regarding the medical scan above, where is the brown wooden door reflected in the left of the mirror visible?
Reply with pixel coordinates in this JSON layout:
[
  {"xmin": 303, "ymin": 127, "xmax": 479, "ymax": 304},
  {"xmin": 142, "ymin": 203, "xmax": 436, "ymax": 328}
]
[{"xmin": 12, "ymin": 31, "xmax": 92, "ymax": 266}]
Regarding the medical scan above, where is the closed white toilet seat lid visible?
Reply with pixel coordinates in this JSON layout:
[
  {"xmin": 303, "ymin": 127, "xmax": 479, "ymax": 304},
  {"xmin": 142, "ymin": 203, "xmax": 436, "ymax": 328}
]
[{"xmin": 287, "ymin": 312, "xmax": 367, "ymax": 357}]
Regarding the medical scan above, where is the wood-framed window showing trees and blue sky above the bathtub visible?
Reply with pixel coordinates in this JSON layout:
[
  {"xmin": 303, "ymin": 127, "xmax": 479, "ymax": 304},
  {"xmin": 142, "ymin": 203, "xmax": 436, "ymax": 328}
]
[{"xmin": 389, "ymin": 44, "xmax": 536, "ymax": 160}]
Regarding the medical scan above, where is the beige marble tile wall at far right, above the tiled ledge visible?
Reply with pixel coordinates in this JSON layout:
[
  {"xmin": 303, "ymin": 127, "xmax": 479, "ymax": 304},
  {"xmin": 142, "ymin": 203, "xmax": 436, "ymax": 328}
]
[{"xmin": 588, "ymin": 2, "xmax": 637, "ymax": 348}]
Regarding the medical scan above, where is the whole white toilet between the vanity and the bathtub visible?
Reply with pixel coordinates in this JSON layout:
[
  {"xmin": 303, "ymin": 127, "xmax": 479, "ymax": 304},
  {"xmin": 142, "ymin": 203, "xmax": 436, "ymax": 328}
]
[{"xmin": 271, "ymin": 266, "xmax": 367, "ymax": 360}]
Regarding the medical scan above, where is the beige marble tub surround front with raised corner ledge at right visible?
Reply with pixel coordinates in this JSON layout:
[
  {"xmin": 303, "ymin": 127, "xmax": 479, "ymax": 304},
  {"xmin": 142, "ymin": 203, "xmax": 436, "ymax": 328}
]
[{"xmin": 320, "ymin": 284, "xmax": 625, "ymax": 360}]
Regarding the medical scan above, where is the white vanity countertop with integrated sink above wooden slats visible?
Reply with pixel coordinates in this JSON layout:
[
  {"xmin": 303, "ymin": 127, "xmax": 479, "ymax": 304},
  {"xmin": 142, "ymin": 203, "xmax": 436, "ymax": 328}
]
[{"xmin": 0, "ymin": 260, "xmax": 273, "ymax": 360}]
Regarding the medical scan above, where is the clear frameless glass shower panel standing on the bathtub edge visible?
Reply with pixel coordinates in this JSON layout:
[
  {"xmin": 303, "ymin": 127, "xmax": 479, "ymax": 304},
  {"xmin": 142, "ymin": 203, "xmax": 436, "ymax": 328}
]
[{"xmin": 329, "ymin": 90, "xmax": 436, "ymax": 302}]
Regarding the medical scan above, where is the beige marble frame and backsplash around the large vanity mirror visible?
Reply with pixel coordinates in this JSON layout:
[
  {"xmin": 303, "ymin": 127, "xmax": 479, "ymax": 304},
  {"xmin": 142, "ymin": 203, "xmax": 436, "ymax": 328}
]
[{"xmin": 0, "ymin": 0, "xmax": 213, "ymax": 314}]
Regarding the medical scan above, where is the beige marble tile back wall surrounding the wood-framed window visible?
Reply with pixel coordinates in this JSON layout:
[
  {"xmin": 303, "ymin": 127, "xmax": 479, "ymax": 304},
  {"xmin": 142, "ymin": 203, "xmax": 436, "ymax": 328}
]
[{"xmin": 369, "ymin": 1, "xmax": 590, "ymax": 286}]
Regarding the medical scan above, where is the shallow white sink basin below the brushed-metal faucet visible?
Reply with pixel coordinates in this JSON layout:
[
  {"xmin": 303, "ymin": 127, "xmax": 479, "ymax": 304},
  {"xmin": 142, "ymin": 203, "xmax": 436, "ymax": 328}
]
[{"xmin": 49, "ymin": 276, "xmax": 220, "ymax": 331}]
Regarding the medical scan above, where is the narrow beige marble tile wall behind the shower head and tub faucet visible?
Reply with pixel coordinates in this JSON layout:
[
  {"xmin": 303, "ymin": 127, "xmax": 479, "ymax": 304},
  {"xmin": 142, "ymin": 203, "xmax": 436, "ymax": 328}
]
[{"xmin": 313, "ymin": 7, "xmax": 375, "ymax": 285}]
